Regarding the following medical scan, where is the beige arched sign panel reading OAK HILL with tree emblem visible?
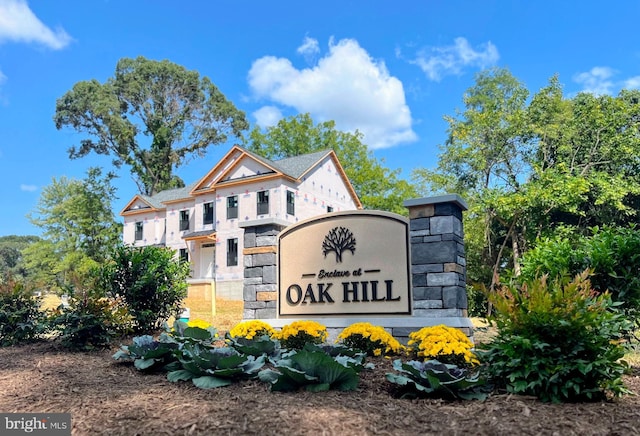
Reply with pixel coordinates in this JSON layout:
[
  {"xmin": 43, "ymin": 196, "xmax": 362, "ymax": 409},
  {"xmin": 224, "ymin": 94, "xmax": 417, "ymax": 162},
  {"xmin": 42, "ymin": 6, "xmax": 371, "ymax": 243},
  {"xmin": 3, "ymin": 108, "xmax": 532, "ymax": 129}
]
[{"xmin": 278, "ymin": 211, "xmax": 411, "ymax": 317}]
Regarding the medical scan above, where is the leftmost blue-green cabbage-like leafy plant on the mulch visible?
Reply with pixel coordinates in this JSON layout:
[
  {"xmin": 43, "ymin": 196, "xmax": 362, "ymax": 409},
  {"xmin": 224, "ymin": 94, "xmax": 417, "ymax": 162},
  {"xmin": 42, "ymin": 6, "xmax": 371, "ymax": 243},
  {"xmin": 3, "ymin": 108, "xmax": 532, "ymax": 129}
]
[{"xmin": 113, "ymin": 335, "xmax": 178, "ymax": 372}]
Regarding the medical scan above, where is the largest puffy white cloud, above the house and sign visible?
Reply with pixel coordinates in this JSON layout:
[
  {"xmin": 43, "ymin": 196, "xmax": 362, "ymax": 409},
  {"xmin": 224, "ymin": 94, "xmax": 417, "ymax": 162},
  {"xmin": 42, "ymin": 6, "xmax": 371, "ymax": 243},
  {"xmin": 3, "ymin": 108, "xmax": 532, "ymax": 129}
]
[{"xmin": 248, "ymin": 38, "xmax": 417, "ymax": 148}]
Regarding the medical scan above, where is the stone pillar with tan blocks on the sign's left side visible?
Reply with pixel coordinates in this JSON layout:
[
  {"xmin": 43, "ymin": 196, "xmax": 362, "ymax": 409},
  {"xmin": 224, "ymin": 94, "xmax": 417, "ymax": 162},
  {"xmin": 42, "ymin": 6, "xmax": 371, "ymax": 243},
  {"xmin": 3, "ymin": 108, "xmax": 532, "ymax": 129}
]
[{"xmin": 240, "ymin": 219, "xmax": 288, "ymax": 319}]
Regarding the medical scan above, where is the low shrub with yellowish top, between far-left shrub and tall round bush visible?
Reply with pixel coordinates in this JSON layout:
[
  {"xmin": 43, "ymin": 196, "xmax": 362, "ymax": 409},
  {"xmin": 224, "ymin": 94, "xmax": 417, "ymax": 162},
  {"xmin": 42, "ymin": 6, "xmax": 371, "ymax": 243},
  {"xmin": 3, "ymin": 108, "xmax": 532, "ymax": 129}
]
[{"xmin": 50, "ymin": 288, "xmax": 131, "ymax": 351}]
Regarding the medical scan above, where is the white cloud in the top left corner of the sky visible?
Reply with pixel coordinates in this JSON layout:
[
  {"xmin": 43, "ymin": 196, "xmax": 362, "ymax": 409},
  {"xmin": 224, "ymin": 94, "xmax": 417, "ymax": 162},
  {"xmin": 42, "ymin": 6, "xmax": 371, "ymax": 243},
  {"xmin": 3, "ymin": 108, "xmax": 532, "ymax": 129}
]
[{"xmin": 0, "ymin": 0, "xmax": 71, "ymax": 50}]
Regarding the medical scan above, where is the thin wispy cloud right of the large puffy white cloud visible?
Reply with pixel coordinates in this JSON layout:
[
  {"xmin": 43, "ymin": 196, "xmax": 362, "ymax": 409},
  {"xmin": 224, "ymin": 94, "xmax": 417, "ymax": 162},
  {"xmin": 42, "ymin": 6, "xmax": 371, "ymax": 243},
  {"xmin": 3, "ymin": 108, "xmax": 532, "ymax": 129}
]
[{"xmin": 408, "ymin": 37, "xmax": 500, "ymax": 81}]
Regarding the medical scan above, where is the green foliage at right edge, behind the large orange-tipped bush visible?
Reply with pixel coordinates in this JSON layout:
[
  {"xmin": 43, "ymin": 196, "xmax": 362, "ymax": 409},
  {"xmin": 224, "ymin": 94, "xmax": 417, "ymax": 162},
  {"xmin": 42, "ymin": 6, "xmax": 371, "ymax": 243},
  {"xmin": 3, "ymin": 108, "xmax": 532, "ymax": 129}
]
[{"xmin": 522, "ymin": 227, "xmax": 640, "ymax": 321}]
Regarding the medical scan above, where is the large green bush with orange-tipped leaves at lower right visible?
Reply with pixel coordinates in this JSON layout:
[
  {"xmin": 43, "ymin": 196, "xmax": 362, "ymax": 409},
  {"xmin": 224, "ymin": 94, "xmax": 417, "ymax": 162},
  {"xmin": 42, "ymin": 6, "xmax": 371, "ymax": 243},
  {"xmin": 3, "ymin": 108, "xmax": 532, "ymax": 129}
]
[{"xmin": 478, "ymin": 272, "xmax": 631, "ymax": 402}]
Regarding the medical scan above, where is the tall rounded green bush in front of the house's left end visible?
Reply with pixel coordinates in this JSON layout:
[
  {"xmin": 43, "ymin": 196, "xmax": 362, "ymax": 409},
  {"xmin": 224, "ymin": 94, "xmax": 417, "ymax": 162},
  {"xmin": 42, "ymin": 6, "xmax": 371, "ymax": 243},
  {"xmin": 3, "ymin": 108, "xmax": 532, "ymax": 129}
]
[{"xmin": 101, "ymin": 247, "xmax": 189, "ymax": 333}]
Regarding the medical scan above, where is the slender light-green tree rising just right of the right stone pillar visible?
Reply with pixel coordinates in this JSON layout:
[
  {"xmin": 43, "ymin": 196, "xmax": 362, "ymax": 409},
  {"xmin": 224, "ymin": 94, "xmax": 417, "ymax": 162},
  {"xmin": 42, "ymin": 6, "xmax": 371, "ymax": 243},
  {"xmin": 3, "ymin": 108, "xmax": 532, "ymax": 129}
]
[{"xmin": 413, "ymin": 68, "xmax": 530, "ymax": 292}]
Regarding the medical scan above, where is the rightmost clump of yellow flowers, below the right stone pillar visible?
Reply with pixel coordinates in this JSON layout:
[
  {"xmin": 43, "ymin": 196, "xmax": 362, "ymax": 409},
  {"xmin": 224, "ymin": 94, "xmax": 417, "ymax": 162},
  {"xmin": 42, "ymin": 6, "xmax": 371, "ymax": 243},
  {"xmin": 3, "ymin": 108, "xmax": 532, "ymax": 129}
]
[{"xmin": 407, "ymin": 324, "xmax": 478, "ymax": 367}]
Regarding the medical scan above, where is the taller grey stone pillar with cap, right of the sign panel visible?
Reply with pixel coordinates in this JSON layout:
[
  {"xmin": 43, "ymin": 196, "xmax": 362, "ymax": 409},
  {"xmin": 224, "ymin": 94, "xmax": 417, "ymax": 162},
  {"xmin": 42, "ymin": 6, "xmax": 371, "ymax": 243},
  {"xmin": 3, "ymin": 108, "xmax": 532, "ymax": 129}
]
[{"xmin": 404, "ymin": 194, "xmax": 467, "ymax": 317}]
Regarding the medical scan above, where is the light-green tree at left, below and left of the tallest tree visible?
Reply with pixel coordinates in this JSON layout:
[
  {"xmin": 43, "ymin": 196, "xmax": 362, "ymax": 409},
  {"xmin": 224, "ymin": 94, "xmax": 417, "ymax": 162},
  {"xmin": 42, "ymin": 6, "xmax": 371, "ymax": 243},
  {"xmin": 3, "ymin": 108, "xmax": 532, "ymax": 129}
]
[{"xmin": 23, "ymin": 168, "xmax": 122, "ymax": 288}]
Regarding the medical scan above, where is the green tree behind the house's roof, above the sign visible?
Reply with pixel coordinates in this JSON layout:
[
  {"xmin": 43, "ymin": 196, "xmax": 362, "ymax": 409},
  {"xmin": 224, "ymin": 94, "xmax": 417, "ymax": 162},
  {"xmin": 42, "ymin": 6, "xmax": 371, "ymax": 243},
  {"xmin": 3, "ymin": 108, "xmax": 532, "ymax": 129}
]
[{"xmin": 244, "ymin": 113, "xmax": 417, "ymax": 215}]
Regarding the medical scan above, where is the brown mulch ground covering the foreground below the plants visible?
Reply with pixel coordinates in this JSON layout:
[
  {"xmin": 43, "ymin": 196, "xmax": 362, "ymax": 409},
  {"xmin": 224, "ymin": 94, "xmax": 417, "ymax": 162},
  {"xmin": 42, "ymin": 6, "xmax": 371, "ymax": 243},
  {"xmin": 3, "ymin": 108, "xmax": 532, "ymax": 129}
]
[{"xmin": 0, "ymin": 342, "xmax": 640, "ymax": 436}]
